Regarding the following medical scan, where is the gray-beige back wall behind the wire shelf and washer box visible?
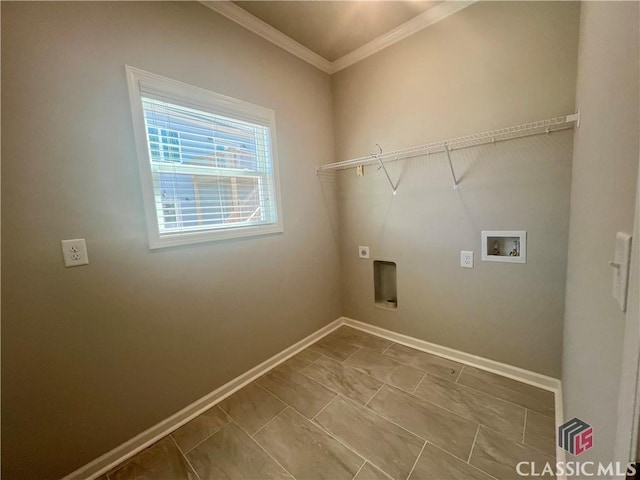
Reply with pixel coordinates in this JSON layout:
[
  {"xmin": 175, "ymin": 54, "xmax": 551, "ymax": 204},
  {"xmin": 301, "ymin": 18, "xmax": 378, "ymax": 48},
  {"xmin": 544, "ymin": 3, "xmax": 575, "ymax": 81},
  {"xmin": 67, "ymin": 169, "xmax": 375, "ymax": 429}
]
[{"xmin": 332, "ymin": 2, "xmax": 579, "ymax": 377}]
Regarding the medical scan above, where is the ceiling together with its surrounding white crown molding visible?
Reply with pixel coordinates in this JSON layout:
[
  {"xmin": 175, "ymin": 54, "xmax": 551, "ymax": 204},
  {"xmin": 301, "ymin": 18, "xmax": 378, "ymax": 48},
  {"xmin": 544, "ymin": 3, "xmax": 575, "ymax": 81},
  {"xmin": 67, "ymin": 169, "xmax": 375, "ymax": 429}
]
[{"xmin": 202, "ymin": 0, "xmax": 477, "ymax": 74}]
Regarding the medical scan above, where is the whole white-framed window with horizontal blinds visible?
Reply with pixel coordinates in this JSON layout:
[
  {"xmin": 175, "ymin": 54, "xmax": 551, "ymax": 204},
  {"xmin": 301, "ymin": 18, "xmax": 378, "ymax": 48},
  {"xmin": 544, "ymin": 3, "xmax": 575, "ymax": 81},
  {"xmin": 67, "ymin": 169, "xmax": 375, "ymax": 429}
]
[{"xmin": 126, "ymin": 67, "xmax": 283, "ymax": 248}]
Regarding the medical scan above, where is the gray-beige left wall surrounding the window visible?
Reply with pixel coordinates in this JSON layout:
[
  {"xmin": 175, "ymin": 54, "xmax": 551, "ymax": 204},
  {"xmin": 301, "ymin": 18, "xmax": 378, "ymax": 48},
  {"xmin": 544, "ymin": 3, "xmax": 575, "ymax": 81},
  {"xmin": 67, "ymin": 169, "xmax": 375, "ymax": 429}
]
[{"xmin": 2, "ymin": 2, "xmax": 341, "ymax": 480}]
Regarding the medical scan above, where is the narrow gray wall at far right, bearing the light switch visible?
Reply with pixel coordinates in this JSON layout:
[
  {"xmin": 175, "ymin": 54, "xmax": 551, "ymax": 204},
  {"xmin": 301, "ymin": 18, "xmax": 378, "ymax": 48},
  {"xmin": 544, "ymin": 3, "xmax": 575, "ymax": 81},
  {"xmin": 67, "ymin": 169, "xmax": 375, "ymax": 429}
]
[{"xmin": 562, "ymin": 2, "xmax": 640, "ymax": 462}]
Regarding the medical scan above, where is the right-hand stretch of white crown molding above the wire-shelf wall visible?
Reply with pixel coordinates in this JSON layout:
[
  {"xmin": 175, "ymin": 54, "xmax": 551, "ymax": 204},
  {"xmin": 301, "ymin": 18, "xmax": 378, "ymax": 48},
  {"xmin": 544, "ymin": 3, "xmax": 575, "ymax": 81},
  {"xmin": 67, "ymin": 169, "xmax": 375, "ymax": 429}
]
[{"xmin": 331, "ymin": 0, "xmax": 476, "ymax": 73}]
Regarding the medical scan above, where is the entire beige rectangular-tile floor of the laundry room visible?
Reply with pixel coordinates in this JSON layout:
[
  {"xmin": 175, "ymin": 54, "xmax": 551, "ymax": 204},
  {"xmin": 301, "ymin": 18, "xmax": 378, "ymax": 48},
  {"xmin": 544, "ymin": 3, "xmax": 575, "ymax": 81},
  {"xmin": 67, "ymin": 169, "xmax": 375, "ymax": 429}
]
[{"xmin": 99, "ymin": 327, "xmax": 555, "ymax": 480}]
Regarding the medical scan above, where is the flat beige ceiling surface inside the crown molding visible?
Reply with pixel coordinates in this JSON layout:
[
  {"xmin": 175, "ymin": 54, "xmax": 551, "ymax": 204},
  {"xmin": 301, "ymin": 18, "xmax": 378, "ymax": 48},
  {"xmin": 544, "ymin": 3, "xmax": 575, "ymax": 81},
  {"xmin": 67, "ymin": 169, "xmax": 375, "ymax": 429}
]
[{"xmin": 233, "ymin": 0, "xmax": 442, "ymax": 62}]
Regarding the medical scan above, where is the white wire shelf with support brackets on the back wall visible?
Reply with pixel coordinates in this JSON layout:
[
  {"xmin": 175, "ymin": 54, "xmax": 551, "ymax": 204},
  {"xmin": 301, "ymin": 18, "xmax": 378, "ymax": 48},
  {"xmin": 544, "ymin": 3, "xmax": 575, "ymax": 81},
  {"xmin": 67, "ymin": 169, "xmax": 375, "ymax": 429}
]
[{"xmin": 316, "ymin": 111, "xmax": 580, "ymax": 195}]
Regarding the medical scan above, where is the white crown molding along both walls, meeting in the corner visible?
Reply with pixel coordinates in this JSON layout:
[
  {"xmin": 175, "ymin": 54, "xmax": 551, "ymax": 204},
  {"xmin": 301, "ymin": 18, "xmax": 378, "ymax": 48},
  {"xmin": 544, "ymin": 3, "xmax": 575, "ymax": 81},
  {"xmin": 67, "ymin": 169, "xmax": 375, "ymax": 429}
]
[{"xmin": 200, "ymin": 0, "xmax": 478, "ymax": 74}]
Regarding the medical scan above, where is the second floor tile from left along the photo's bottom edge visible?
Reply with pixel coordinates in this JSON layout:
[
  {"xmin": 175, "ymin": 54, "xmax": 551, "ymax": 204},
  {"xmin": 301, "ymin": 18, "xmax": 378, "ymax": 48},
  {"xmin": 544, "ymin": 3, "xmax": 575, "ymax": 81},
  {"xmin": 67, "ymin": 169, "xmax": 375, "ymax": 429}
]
[{"xmin": 185, "ymin": 423, "xmax": 292, "ymax": 480}]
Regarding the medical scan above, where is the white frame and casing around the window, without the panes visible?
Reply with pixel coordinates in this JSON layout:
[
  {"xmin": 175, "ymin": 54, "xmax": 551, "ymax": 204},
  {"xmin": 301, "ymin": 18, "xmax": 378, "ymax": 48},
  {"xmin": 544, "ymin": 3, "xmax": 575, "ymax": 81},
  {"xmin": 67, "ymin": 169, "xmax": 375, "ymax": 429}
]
[{"xmin": 125, "ymin": 65, "xmax": 284, "ymax": 250}]
